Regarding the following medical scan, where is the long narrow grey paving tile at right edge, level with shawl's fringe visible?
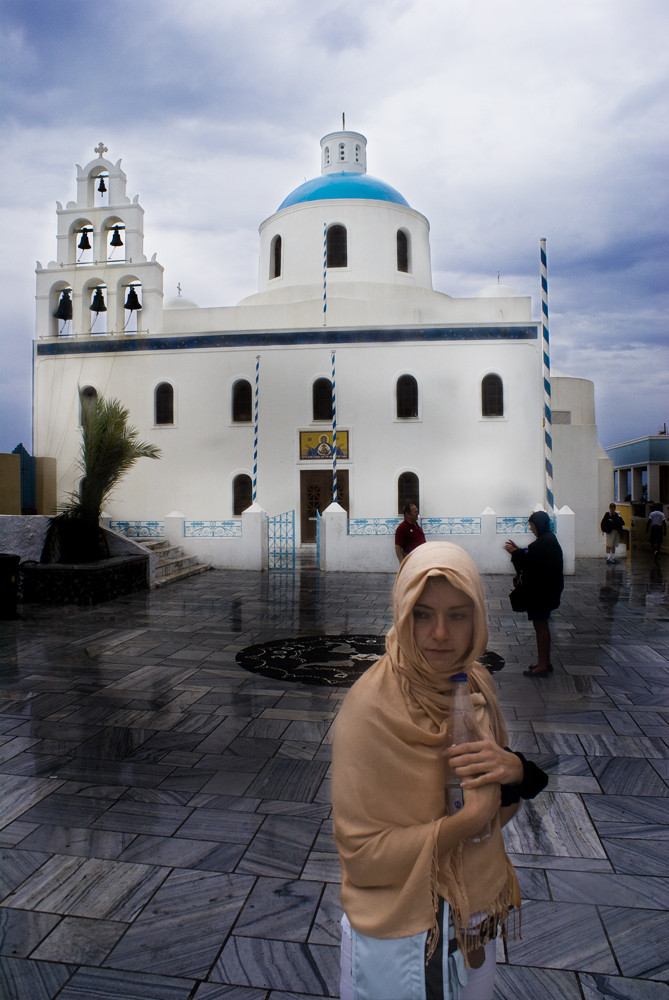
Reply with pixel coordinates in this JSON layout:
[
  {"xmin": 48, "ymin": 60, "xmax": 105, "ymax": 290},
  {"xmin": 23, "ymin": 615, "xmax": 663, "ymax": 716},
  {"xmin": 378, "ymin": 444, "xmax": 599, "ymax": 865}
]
[{"xmin": 547, "ymin": 869, "xmax": 669, "ymax": 910}]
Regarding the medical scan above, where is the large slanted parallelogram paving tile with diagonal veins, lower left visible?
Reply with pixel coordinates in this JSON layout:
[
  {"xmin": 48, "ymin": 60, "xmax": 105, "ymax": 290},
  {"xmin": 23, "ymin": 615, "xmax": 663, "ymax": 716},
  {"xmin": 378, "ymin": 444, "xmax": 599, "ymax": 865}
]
[{"xmin": 104, "ymin": 869, "xmax": 253, "ymax": 979}]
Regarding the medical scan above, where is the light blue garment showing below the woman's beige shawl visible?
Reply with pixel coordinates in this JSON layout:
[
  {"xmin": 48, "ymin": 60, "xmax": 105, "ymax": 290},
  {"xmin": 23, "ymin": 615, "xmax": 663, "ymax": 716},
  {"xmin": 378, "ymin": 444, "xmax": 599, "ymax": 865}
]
[{"xmin": 341, "ymin": 904, "xmax": 467, "ymax": 1000}]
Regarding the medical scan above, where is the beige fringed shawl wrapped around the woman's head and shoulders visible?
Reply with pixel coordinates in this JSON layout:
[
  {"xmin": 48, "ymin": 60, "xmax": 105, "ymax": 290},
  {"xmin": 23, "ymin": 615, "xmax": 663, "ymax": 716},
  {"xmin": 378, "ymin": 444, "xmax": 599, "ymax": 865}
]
[{"xmin": 332, "ymin": 542, "xmax": 520, "ymax": 948}]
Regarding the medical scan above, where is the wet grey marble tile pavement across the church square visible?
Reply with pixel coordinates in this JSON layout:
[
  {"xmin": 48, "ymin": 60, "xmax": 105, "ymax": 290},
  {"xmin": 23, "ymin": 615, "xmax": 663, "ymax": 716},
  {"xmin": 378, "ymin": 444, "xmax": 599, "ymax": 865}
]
[{"xmin": 0, "ymin": 553, "xmax": 669, "ymax": 1000}]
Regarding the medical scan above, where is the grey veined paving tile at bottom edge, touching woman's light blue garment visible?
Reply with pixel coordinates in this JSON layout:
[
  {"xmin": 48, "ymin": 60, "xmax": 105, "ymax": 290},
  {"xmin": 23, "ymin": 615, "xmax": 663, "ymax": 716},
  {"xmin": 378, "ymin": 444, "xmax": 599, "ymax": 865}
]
[{"xmin": 209, "ymin": 934, "xmax": 339, "ymax": 997}]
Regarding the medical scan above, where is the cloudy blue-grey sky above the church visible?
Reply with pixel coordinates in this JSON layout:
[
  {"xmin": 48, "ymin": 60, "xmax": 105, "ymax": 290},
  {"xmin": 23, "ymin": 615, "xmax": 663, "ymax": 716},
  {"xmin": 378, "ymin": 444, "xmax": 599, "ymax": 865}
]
[{"xmin": 0, "ymin": 0, "xmax": 669, "ymax": 451}]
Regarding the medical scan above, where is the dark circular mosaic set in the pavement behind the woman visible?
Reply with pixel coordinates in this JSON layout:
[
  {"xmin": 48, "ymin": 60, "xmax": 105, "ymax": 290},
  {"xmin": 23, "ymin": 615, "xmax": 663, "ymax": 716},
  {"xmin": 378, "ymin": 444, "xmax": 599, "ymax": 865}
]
[{"xmin": 235, "ymin": 635, "xmax": 504, "ymax": 687}]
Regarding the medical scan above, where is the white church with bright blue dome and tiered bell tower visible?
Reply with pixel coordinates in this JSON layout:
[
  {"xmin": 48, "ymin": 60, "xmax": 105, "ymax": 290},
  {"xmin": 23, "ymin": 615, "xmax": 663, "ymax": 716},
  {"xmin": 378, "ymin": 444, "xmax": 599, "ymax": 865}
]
[{"xmin": 33, "ymin": 130, "xmax": 612, "ymax": 571}]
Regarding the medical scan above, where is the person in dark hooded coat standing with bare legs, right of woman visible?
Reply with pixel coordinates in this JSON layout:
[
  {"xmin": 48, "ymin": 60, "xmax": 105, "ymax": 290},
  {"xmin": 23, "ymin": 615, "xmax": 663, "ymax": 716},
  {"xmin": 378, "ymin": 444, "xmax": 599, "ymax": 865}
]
[{"xmin": 504, "ymin": 510, "xmax": 564, "ymax": 677}]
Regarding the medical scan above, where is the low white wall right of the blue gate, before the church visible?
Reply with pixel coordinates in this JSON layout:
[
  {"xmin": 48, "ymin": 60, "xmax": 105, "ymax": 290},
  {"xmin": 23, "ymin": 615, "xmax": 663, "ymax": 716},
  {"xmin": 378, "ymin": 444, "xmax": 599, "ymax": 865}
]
[{"xmin": 320, "ymin": 504, "xmax": 575, "ymax": 575}]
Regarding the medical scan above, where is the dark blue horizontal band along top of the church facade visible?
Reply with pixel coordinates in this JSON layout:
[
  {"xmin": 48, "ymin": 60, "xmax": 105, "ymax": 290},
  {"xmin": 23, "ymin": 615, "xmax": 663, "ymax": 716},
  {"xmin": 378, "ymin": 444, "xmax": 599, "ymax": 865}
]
[{"xmin": 36, "ymin": 326, "xmax": 538, "ymax": 355}]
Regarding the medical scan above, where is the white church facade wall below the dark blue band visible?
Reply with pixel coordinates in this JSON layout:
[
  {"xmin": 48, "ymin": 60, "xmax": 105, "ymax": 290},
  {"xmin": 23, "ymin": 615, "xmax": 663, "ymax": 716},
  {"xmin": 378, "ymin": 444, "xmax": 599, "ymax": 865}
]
[{"xmin": 36, "ymin": 330, "xmax": 543, "ymax": 536}]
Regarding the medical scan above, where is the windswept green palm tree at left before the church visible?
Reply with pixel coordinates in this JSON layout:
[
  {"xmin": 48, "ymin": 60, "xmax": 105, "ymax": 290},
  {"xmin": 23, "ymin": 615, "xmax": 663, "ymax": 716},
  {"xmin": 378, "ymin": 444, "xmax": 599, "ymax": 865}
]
[{"xmin": 42, "ymin": 393, "xmax": 160, "ymax": 563}]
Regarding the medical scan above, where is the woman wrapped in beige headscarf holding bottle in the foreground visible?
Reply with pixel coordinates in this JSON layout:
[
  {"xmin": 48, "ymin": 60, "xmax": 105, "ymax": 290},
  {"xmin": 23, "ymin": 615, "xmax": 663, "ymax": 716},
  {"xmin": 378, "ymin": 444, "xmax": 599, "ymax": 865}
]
[{"xmin": 333, "ymin": 542, "xmax": 545, "ymax": 1000}]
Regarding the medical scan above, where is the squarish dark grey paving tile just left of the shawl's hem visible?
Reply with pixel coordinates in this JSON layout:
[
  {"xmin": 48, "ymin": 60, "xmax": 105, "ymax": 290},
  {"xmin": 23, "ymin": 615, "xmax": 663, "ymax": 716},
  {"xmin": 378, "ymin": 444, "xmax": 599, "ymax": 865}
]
[{"xmin": 234, "ymin": 878, "xmax": 320, "ymax": 944}]
